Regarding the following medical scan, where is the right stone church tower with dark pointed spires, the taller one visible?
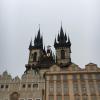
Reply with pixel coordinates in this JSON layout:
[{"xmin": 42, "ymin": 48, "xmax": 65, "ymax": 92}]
[{"xmin": 54, "ymin": 26, "xmax": 71, "ymax": 65}]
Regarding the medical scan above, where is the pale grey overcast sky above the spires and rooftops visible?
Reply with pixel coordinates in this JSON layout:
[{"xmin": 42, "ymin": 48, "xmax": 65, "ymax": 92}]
[{"xmin": 0, "ymin": 0, "xmax": 100, "ymax": 76}]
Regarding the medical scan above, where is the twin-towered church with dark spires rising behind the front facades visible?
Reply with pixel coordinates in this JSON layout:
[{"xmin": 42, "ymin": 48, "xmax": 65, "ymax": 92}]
[{"xmin": 26, "ymin": 26, "xmax": 71, "ymax": 71}]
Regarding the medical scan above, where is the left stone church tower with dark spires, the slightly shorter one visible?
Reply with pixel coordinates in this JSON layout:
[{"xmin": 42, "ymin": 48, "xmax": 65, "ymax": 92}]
[{"xmin": 28, "ymin": 28, "xmax": 43, "ymax": 65}]
